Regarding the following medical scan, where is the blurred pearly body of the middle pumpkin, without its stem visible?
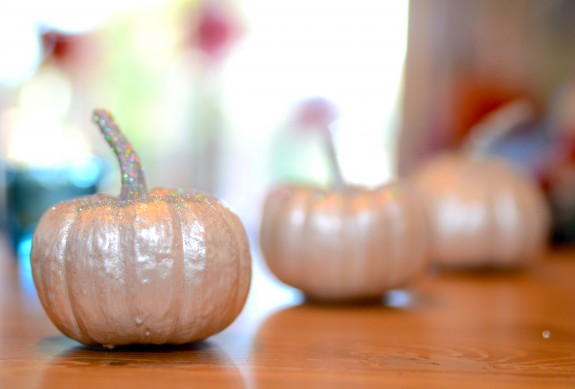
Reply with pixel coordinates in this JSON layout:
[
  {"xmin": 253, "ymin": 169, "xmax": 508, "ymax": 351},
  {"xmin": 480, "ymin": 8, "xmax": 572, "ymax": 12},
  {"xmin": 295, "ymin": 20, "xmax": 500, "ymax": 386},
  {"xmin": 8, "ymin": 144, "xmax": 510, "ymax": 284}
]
[{"xmin": 260, "ymin": 184, "xmax": 428, "ymax": 301}]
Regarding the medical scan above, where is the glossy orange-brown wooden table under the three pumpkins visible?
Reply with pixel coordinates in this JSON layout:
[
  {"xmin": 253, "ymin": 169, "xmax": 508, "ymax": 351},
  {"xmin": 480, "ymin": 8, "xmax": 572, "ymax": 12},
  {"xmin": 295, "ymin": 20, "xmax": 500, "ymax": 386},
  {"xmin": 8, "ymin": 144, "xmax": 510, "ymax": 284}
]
[{"xmin": 0, "ymin": 238, "xmax": 575, "ymax": 389}]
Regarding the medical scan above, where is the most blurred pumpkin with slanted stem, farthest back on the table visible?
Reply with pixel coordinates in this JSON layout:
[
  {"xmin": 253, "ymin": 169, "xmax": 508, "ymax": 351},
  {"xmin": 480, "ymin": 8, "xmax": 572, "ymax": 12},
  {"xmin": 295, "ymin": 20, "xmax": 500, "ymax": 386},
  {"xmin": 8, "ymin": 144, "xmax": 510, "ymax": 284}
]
[{"xmin": 412, "ymin": 101, "xmax": 550, "ymax": 267}]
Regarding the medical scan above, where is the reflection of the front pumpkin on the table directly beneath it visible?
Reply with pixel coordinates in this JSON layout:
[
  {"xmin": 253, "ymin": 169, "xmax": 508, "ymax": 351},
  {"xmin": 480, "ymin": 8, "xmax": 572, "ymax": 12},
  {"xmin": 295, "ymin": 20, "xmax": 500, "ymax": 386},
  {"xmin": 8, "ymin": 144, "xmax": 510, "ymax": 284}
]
[{"xmin": 37, "ymin": 336, "xmax": 246, "ymax": 388}]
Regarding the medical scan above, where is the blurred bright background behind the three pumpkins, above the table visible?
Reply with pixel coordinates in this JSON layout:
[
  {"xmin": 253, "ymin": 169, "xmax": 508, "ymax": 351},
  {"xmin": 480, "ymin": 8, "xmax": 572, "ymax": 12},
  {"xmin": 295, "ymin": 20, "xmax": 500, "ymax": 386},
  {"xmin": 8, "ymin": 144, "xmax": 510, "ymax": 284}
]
[{"xmin": 0, "ymin": 0, "xmax": 575, "ymax": 272}]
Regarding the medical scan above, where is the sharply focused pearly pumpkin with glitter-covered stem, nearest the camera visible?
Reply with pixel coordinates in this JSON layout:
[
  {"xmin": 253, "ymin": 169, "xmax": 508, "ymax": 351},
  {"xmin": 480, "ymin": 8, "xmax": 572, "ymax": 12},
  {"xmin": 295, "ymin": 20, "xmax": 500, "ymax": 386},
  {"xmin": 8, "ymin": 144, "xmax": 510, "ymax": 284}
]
[{"xmin": 31, "ymin": 110, "xmax": 251, "ymax": 347}]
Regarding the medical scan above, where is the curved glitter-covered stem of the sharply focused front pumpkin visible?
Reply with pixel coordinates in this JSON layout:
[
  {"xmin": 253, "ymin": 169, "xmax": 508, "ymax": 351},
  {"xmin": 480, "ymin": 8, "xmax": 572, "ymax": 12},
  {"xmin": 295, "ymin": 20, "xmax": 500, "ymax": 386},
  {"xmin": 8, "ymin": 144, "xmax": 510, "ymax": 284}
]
[{"xmin": 92, "ymin": 109, "xmax": 148, "ymax": 201}]
